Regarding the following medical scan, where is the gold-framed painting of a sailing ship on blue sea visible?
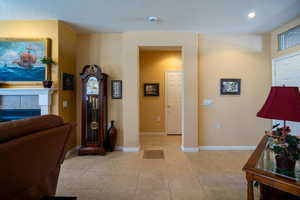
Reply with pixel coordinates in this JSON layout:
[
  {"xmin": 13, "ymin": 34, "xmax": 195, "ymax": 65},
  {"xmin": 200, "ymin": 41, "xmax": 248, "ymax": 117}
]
[{"xmin": 0, "ymin": 38, "xmax": 51, "ymax": 84}]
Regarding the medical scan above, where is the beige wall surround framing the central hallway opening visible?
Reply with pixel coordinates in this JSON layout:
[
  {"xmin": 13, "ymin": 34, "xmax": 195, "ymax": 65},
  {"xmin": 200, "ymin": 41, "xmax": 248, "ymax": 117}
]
[{"xmin": 120, "ymin": 32, "xmax": 199, "ymax": 152}]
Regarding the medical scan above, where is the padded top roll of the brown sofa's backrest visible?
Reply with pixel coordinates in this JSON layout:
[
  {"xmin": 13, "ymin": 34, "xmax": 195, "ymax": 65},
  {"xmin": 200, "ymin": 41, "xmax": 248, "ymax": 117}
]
[{"xmin": 0, "ymin": 115, "xmax": 64, "ymax": 143}]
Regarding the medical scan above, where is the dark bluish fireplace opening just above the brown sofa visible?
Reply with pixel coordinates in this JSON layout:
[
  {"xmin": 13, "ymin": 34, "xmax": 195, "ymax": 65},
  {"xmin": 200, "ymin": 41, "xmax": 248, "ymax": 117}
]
[{"xmin": 0, "ymin": 109, "xmax": 41, "ymax": 122}]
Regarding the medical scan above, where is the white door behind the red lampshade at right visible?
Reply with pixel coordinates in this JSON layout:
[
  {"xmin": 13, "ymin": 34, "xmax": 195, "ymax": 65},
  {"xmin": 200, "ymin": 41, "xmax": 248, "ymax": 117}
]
[{"xmin": 273, "ymin": 52, "xmax": 300, "ymax": 136}]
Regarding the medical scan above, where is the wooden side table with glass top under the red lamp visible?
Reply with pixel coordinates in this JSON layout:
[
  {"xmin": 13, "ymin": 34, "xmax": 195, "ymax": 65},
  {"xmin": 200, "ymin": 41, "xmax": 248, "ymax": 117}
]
[{"xmin": 243, "ymin": 136, "xmax": 300, "ymax": 200}]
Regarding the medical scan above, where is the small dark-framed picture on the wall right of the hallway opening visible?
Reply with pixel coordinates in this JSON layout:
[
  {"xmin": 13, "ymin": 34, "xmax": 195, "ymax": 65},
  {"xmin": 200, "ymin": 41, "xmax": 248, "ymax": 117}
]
[{"xmin": 220, "ymin": 78, "xmax": 241, "ymax": 95}]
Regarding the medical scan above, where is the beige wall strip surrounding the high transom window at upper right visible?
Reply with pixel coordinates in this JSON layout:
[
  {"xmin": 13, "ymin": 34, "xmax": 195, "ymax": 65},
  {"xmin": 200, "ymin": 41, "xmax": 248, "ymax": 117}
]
[{"xmin": 271, "ymin": 17, "xmax": 300, "ymax": 58}]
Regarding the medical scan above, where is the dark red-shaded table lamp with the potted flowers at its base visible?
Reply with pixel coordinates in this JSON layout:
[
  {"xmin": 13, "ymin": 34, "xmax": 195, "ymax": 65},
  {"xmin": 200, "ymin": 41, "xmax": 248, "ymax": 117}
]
[{"xmin": 256, "ymin": 86, "xmax": 300, "ymax": 172}]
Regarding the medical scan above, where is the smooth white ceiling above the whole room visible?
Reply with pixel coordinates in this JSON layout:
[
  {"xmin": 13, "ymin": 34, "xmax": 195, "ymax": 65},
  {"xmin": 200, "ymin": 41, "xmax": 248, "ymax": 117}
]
[{"xmin": 0, "ymin": 0, "xmax": 300, "ymax": 33}]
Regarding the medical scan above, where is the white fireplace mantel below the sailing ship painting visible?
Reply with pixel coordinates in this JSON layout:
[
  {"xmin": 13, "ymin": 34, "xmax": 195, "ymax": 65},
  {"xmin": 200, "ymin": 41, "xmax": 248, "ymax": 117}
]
[{"xmin": 0, "ymin": 88, "xmax": 57, "ymax": 115}]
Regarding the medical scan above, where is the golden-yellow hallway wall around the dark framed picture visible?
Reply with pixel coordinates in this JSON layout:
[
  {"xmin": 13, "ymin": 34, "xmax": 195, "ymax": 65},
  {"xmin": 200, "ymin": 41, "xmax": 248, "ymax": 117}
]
[{"xmin": 139, "ymin": 51, "xmax": 182, "ymax": 132}]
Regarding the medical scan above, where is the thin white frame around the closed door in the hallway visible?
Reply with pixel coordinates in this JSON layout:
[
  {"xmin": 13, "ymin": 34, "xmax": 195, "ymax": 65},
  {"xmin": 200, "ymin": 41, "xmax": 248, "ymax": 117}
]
[{"xmin": 164, "ymin": 69, "xmax": 184, "ymax": 136}]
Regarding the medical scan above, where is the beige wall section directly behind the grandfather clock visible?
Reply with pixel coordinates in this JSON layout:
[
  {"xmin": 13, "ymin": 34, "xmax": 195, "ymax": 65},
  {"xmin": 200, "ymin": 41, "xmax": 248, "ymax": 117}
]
[{"xmin": 76, "ymin": 33, "xmax": 123, "ymax": 145}]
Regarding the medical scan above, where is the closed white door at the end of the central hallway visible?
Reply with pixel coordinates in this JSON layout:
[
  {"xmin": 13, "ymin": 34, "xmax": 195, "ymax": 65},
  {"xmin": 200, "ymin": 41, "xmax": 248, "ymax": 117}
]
[{"xmin": 165, "ymin": 71, "xmax": 182, "ymax": 135}]
